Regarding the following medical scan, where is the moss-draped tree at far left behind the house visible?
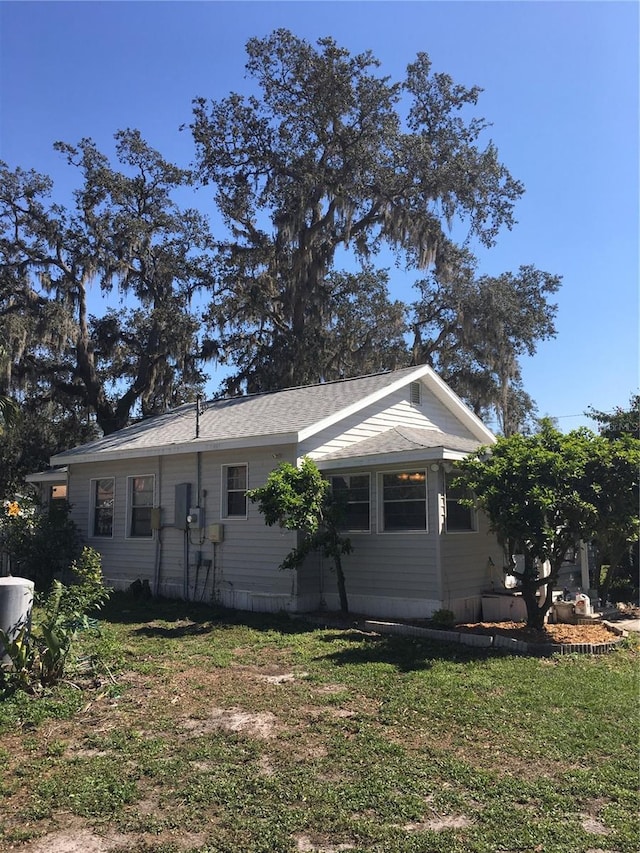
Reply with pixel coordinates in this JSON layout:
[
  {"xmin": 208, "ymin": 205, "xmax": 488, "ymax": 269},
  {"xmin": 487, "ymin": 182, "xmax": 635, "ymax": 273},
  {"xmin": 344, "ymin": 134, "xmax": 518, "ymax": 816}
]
[{"xmin": 0, "ymin": 130, "xmax": 211, "ymax": 434}]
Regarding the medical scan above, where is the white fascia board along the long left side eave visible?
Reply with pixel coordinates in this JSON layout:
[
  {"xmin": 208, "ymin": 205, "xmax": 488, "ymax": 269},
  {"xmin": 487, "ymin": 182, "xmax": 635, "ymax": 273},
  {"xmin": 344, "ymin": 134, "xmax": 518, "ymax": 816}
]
[{"xmin": 50, "ymin": 432, "xmax": 298, "ymax": 465}]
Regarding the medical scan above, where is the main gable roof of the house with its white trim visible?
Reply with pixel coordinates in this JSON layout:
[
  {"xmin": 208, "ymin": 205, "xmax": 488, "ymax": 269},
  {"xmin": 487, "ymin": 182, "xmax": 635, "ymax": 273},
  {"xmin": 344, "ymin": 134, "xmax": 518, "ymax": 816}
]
[{"xmin": 51, "ymin": 365, "xmax": 494, "ymax": 465}]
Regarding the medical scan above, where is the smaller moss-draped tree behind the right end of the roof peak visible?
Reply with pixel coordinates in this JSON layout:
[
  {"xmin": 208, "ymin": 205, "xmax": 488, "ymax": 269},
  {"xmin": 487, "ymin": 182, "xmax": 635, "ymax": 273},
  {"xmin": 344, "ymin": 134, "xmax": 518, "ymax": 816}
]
[{"xmin": 411, "ymin": 251, "xmax": 560, "ymax": 435}]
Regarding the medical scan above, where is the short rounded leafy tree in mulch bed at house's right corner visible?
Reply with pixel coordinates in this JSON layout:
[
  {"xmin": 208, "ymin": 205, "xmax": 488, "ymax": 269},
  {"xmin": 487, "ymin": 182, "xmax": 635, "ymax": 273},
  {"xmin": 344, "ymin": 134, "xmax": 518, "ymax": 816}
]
[{"xmin": 457, "ymin": 421, "xmax": 599, "ymax": 628}]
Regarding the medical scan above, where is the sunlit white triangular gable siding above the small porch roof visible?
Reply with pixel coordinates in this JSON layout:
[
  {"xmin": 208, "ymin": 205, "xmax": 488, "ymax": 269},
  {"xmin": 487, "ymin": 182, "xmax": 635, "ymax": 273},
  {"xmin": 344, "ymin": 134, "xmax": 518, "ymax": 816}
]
[{"xmin": 298, "ymin": 385, "xmax": 474, "ymax": 458}]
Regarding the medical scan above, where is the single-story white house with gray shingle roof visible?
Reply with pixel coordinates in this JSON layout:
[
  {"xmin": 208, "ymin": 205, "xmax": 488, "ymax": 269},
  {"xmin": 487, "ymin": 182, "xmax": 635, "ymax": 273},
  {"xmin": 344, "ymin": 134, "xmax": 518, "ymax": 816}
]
[{"xmin": 35, "ymin": 365, "xmax": 503, "ymax": 619}]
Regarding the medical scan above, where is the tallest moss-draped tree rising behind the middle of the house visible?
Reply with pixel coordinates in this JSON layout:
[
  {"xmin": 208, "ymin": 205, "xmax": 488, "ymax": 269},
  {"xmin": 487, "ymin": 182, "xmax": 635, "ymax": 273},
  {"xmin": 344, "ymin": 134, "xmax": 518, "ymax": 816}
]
[{"xmin": 191, "ymin": 29, "xmax": 523, "ymax": 391}]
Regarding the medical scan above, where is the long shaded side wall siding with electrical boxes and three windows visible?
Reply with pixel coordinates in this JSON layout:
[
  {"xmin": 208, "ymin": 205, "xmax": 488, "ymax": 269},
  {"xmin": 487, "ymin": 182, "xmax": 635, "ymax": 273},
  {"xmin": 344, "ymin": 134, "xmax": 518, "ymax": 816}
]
[{"xmin": 70, "ymin": 440, "xmax": 319, "ymax": 611}]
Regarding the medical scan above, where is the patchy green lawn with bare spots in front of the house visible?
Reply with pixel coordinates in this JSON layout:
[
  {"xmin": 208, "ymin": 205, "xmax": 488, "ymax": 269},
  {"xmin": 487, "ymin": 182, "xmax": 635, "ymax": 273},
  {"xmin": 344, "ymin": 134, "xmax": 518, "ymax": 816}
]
[{"xmin": 0, "ymin": 597, "xmax": 640, "ymax": 853}]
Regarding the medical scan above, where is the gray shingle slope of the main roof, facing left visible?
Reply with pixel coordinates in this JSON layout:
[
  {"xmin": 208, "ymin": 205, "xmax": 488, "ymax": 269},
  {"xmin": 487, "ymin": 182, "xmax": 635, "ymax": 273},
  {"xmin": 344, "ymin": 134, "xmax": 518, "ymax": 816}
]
[{"xmin": 53, "ymin": 367, "xmax": 428, "ymax": 463}]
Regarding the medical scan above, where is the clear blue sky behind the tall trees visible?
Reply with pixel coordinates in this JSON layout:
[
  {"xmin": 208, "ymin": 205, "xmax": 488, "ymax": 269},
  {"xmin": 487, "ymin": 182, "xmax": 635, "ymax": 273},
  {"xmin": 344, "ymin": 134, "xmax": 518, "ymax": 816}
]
[{"xmin": 0, "ymin": 0, "xmax": 640, "ymax": 429}]
